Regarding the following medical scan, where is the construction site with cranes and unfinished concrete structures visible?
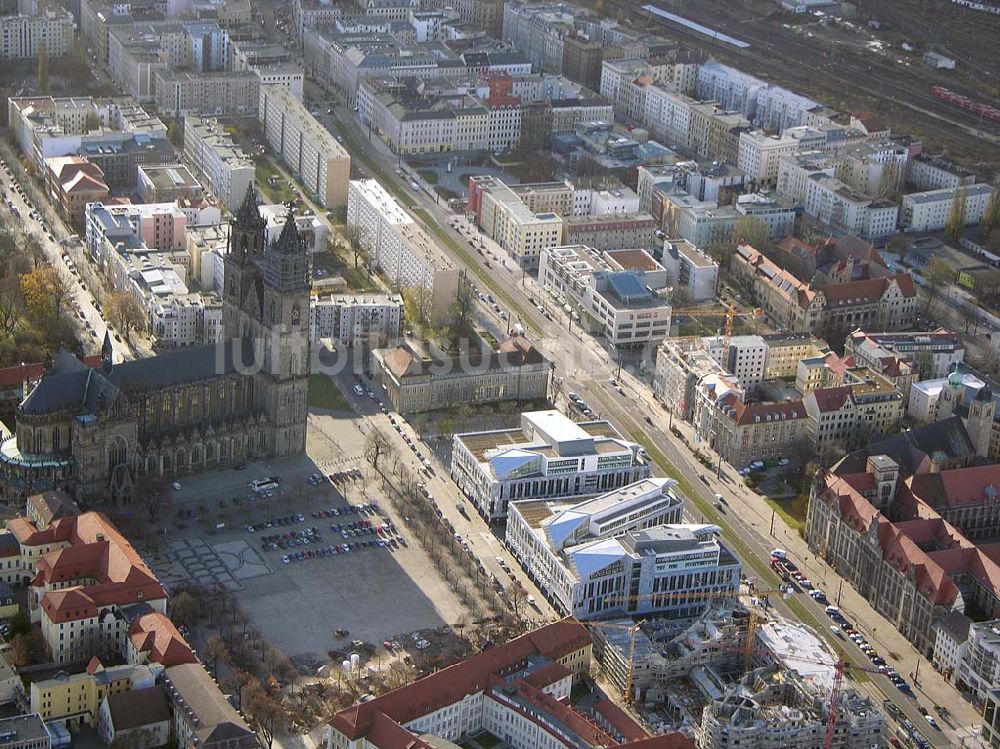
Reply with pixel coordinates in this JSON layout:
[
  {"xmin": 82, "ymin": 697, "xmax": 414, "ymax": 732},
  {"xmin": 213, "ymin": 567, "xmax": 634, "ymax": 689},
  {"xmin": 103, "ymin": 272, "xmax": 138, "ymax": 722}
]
[{"xmin": 591, "ymin": 591, "xmax": 892, "ymax": 749}]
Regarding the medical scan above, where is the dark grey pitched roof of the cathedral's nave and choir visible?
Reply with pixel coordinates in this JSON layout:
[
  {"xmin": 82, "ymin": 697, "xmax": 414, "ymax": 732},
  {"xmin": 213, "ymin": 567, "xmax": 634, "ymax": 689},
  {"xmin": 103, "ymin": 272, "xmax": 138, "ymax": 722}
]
[{"xmin": 21, "ymin": 338, "xmax": 256, "ymax": 414}]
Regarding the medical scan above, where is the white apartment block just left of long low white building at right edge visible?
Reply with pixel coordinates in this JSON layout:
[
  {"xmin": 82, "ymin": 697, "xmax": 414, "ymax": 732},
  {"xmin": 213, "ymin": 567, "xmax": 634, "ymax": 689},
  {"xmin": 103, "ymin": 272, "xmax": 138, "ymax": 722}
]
[{"xmin": 802, "ymin": 174, "xmax": 909, "ymax": 239}]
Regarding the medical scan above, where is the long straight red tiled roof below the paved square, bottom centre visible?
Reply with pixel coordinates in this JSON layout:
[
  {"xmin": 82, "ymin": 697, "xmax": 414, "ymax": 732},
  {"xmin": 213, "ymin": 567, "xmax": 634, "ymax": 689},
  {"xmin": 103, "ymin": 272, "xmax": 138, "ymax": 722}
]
[{"xmin": 331, "ymin": 617, "xmax": 590, "ymax": 741}]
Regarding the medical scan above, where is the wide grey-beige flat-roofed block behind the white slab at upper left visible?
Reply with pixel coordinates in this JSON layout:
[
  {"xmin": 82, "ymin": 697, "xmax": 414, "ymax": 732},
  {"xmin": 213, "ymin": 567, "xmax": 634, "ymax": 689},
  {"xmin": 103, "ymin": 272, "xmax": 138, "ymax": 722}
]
[{"xmin": 155, "ymin": 70, "xmax": 260, "ymax": 117}]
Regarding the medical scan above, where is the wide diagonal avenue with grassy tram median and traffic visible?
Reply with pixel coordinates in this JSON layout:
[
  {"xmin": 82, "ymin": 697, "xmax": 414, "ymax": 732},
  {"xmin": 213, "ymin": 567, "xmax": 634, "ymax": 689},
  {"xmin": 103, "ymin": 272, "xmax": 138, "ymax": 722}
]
[{"xmin": 308, "ymin": 90, "xmax": 979, "ymax": 746}]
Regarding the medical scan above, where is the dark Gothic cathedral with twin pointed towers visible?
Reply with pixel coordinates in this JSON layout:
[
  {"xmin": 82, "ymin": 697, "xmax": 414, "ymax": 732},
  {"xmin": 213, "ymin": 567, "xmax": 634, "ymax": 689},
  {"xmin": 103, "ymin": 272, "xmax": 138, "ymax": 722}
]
[{"xmin": 0, "ymin": 186, "xmax": 311, "ymax": 502}]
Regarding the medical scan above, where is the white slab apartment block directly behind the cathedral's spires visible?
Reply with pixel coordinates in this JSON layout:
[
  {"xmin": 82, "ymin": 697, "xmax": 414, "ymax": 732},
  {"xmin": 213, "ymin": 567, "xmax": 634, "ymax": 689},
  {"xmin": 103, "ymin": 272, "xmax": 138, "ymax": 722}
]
[{"xmin": 184, "ymin": 115, "xmax": 255, "ymax": 211}]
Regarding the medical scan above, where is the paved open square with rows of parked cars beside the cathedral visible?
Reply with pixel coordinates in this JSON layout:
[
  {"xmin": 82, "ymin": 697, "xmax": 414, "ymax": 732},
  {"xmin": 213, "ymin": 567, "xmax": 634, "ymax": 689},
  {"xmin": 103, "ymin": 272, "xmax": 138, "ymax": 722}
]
[{"xmin": 147, "ymin": 414, "xmax": 466, "ymax": 661}]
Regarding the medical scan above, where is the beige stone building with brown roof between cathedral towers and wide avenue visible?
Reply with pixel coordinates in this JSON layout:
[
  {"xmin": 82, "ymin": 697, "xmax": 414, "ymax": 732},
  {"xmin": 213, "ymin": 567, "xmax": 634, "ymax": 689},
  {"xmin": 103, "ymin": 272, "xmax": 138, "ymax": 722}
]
[{"xmin": 372, "ymin": 336, "xmax": 552, "ymax": 414}]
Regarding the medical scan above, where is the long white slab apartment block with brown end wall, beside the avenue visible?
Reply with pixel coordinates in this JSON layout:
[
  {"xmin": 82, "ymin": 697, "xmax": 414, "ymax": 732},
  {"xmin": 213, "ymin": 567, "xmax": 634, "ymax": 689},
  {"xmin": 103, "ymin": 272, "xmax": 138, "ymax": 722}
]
[{"xmin": 347, "ymin": 179, "xmax": 459, "ymax": 321}]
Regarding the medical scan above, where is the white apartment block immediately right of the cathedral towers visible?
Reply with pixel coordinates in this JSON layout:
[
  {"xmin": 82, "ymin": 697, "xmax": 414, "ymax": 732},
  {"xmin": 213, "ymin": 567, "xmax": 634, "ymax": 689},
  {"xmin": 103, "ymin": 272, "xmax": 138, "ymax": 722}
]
[{"xmin": 309, "ymin": 294, "xmax": 403, "ymax": 346}]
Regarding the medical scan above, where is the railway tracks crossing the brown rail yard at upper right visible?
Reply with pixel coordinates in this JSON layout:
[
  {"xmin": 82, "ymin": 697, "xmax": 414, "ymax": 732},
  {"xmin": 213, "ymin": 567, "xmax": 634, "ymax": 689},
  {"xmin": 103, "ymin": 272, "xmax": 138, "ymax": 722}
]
[{"xmin": 605, "ymin": 0, "xmax": 1000, "ymax": 168}]
